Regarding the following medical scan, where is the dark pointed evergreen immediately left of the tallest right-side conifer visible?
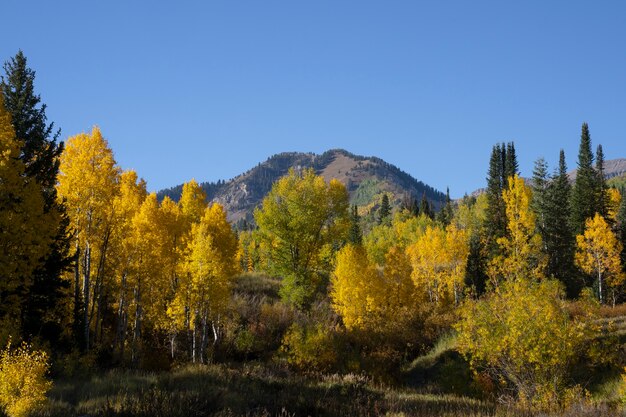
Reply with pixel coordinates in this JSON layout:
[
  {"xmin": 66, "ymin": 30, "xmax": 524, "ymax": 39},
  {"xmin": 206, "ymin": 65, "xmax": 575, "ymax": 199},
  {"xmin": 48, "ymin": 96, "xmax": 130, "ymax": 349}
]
[{"xmin": 542, "ymin": 150, "xmax": 582, "ymax": 297}]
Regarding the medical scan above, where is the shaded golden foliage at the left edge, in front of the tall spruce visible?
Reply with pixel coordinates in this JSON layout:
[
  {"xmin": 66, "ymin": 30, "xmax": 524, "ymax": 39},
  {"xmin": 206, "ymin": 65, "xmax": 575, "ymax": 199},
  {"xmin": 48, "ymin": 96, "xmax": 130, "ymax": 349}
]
[{"xmin": 0, "ymin": 97, "xmax": 51, "ymax": 343}]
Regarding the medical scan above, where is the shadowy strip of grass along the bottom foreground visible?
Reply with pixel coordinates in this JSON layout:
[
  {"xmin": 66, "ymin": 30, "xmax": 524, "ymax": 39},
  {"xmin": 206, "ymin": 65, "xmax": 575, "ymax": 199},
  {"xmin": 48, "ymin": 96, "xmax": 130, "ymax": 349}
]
[{"xmin": 33, "ymin": 360, "xmax": 626, "ymax": 417}]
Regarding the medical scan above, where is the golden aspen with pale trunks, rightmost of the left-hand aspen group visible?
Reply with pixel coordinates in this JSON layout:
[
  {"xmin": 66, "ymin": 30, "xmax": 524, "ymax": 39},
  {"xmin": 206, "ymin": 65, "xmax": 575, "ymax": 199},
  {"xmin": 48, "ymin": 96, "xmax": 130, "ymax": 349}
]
[{"xmin": 170, "ymin": 204, "xmax": 239, "ymax": 363}]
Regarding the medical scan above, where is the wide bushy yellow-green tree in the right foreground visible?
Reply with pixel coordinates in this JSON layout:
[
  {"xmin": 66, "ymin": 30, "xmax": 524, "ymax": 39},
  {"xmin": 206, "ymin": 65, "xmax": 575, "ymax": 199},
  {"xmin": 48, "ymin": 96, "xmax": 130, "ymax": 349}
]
[{"xmin": 456, "ymin": 279, "xmax": 593, "ymax": 408}]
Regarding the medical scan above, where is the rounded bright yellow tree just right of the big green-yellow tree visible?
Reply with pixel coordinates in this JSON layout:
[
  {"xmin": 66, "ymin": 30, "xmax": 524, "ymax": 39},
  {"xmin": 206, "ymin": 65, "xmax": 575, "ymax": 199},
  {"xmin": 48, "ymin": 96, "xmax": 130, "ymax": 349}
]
[{"xmin": 330, "ymin": 245, "xmax": 387, "ymax": 329}]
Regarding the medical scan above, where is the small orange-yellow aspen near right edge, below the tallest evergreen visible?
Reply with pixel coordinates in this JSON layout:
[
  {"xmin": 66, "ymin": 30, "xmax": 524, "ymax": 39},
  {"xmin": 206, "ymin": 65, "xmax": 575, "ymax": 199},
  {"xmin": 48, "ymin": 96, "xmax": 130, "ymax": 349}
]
[{"xmin": 575, "ymin": 213, "xmax": 625, "ymax": 303}]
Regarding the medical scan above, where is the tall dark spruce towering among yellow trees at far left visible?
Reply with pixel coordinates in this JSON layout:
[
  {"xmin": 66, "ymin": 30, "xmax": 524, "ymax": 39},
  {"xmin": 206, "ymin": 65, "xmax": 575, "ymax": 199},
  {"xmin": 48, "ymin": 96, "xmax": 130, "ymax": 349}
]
[{"xmin": 0, "ymin": 51, "xmax": 71, "ymax": 340}]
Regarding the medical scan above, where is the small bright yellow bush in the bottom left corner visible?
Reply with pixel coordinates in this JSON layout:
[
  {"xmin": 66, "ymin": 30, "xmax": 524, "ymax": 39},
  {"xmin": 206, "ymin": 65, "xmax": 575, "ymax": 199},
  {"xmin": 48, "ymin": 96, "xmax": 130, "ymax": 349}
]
[{"xmin": 0, "ymin": 342, "xmax": 52, "ymax": 417}]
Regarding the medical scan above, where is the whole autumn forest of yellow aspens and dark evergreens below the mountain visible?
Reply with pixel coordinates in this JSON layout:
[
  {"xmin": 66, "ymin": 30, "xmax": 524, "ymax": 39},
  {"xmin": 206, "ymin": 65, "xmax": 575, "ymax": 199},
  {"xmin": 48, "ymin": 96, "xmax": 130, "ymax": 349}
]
[{"xmin": 0, "ymin": 52, "xmax": 626, "ymax": 417}]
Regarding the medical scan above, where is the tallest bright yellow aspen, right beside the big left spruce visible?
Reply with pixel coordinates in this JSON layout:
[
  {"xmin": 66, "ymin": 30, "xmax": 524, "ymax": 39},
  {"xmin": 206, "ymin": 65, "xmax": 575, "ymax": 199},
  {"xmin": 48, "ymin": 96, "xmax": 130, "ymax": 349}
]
[{"xmin": 57, "ymin": 127, "xmax": 119, "ymax": 348}]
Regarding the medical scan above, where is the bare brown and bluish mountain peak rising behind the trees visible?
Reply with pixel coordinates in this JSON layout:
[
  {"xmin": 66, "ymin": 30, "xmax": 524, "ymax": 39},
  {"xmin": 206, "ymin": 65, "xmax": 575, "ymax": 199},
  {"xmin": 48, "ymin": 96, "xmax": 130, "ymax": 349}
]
[{"xmin": 157, "ymin": 149, "xmax": 445, "ymax": 222}]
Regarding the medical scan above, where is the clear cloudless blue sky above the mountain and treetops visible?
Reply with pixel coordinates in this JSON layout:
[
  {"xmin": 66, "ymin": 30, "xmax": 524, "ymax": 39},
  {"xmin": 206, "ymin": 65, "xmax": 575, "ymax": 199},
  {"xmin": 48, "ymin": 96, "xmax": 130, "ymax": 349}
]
[{"xmin": 0, "ymin": 0, "xmax": 626, "ymax": 197}]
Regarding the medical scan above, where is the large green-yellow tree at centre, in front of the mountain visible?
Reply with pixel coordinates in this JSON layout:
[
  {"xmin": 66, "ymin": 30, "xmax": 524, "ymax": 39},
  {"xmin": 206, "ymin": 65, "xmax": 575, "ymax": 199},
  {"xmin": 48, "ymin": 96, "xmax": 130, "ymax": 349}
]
[{"xmin": 254, "ymin": 169, "xmax": 349, "ymax": 308}]
